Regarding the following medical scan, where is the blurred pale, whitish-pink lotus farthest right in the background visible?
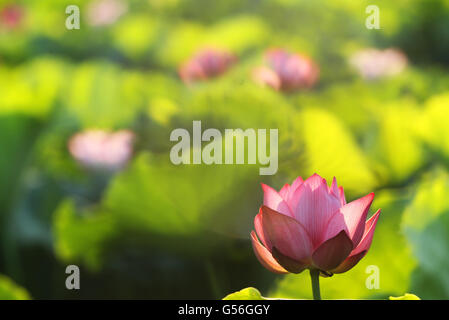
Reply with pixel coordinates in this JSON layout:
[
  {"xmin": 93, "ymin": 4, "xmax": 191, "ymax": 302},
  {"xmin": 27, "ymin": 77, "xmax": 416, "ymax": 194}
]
[{"xmin": 350, "ymin": 48, "xmax": 407, "ymax": 80}]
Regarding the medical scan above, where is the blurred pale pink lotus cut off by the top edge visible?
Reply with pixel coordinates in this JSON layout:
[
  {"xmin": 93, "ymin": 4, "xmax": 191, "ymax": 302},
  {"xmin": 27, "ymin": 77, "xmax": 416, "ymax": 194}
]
[{"xmin": 87, "ymin": 0, "xmax": 128, "ymax": 26}]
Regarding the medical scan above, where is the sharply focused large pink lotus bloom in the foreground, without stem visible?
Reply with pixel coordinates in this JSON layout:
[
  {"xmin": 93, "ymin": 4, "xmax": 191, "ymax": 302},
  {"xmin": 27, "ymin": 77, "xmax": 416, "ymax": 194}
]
[{"xmin": 251, "ymin": 174, "xmax": 380, "ymax": 276}]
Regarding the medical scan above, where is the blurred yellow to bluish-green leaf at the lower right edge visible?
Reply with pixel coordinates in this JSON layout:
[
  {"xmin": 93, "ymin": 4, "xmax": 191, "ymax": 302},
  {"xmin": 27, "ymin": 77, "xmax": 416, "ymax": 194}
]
[{"xmin": 402, "ymin": 170, "xmax": 449, "ymax": 298}]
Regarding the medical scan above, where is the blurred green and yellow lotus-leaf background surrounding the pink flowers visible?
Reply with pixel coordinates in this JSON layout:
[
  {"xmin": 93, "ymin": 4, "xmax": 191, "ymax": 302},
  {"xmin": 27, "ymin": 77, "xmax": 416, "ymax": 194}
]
[{"xmin": 0, "ymin": 0, "xmax": 449, "ymax": 299}]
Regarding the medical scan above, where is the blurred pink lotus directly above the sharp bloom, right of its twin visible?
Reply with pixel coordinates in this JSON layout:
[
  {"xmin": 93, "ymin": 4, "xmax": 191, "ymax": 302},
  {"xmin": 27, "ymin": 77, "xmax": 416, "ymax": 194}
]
[{"xmin": 253, "ymin": 49, "xmax": 319, "ymax": 91}]
